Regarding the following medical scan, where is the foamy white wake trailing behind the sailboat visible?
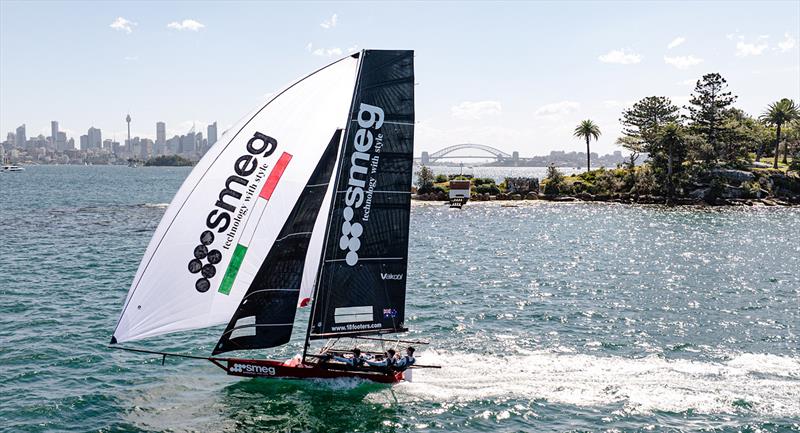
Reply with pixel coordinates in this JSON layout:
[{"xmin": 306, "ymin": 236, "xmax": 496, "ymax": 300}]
[{"xmin": 396, "ymin": 351, "xmax": 800, "ymax": 417}]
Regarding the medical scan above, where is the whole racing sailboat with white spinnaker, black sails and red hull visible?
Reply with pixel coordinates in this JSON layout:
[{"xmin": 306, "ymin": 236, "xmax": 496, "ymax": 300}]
[{"xmin": 109, "ymin": 50, "xmax": 424, "ymax": 383}]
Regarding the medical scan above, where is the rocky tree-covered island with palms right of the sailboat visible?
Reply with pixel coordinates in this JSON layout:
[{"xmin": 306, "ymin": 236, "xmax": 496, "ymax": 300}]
[{"xmin": 416, "ymin": 73, "xmax": 800, "ymax": 205}]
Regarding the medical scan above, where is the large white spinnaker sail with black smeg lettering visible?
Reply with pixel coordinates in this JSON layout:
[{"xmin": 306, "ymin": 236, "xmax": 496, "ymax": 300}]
[{"xmin": 113, "ymin": 57, "xmax": 358, "ymax": 343}]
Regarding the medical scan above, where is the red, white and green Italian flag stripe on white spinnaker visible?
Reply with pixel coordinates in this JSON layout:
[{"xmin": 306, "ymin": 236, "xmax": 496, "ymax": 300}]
[{"xmin": 219, "ymin": 152, "xmax": 292, "ymax": 295}]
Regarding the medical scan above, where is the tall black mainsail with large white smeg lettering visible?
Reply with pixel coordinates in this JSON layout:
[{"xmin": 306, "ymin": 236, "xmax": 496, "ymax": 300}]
[{"xmin": 309, "ymin": 50, "xmax": 414, "ymax": 339}]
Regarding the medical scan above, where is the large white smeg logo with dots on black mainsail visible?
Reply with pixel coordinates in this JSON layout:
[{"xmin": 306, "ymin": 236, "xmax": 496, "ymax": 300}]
[{"xmin": 339, "ymin": 103, "xmax": 384, "ymax": 266}]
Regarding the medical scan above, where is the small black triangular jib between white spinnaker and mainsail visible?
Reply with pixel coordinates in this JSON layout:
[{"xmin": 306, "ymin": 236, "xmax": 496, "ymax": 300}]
[{"xmin": 213, "ymin": 130, "xmax": 341, "ymax": 355}]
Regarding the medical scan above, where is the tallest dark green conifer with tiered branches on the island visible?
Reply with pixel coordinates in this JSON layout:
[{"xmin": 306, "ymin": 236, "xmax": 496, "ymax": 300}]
[{"xmin": 685, "ymin": 73, "xmax": 736, "ymax": 163}]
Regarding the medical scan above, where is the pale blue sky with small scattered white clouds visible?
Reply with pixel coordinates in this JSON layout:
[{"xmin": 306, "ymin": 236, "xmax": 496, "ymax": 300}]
[{"xmin": 0, "ymin": 0, "xmax": 800, "ymax": 157}]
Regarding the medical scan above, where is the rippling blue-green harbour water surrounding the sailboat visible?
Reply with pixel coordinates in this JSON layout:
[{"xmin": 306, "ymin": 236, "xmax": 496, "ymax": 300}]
[{"xmin": 0, "ymin": 166, "xmax": 800, "ymax": 432}]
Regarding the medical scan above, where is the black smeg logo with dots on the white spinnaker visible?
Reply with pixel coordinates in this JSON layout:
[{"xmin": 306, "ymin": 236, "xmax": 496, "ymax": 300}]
[{"xmin": 188, "ymin": 132, "xmax": 278, "ymax": 293}]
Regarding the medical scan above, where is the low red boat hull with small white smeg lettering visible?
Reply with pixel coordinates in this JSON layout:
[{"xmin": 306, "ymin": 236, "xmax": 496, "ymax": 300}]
[{"xmin": 215, "ymin": 358, "xmax": 403, "ymax": 383}]
